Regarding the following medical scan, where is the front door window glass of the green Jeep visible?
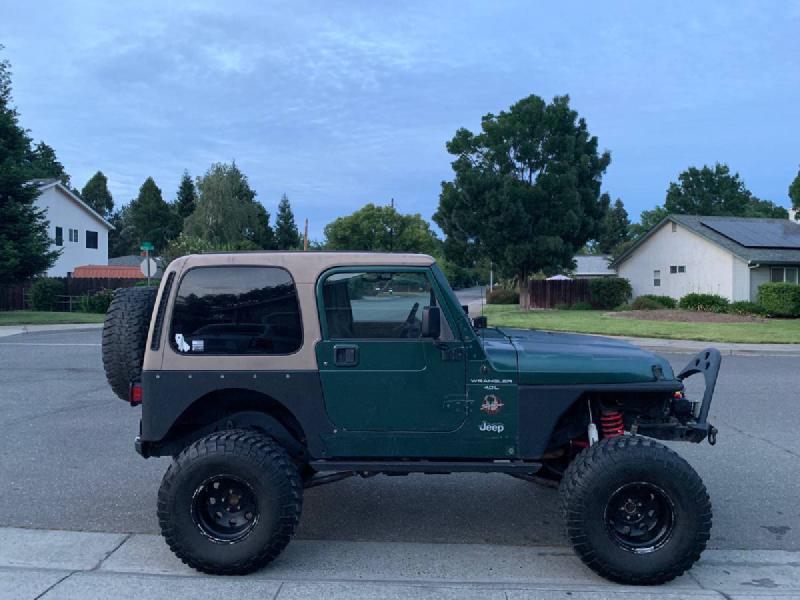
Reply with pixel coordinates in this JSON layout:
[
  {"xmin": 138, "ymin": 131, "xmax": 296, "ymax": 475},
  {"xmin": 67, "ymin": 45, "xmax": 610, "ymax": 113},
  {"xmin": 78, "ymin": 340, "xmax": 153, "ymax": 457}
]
[{"xmin": 322, "ymin": 272, "xmax": 436, "ymax": 339}]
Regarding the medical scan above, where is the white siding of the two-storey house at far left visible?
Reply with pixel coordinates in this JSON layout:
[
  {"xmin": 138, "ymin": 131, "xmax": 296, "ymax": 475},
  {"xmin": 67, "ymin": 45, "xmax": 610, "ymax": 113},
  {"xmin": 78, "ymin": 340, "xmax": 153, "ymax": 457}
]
[{"xmin": 36, "ymin": 186, "xmax": 108, "ymax": 277}]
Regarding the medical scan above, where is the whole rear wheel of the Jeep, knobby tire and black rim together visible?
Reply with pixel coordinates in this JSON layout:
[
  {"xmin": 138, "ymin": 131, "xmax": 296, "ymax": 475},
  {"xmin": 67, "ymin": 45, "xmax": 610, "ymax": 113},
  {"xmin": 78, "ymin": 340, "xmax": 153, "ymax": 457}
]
[{"xmin": 158, "ymin": 430, "xmax": 303, "ymax": 575}]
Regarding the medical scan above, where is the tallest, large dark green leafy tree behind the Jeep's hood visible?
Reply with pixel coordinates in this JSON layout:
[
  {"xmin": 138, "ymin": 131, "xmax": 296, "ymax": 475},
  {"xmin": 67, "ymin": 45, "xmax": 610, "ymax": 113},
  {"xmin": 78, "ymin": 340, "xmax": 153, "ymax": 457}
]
[{"xmin": 433, "ymin": 95, "xmax": 611, "ymax": 298}]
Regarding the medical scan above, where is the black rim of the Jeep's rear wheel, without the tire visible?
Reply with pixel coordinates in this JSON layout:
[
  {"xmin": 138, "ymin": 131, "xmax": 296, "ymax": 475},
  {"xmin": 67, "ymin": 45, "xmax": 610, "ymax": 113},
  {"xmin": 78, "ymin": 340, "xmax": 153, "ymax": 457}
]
[{"xmin": 192, "ymin": 475, "xmax": 259, "ymax": 544}]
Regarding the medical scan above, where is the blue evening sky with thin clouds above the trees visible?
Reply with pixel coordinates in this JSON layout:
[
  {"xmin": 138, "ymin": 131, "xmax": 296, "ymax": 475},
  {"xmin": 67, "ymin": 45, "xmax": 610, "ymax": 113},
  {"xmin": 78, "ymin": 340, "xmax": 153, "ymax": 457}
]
[{"xmin": 0, "ymin": 0, "xmax": 800, "ymax": 239}]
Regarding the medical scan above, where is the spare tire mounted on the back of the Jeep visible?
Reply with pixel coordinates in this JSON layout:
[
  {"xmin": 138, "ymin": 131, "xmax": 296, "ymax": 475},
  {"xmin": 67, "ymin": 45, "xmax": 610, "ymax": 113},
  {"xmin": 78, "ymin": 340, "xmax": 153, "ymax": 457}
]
[{"xmin": 103, "ymin": 287, "xmax": 158, "ymax": 402}]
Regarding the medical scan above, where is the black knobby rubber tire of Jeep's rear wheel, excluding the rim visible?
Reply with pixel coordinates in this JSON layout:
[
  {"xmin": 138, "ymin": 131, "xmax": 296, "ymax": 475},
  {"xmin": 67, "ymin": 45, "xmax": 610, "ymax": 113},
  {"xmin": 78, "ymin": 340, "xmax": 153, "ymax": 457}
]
[{"xmin": 158, "ymin": 430, "xmax": 303, "ymax": 575}]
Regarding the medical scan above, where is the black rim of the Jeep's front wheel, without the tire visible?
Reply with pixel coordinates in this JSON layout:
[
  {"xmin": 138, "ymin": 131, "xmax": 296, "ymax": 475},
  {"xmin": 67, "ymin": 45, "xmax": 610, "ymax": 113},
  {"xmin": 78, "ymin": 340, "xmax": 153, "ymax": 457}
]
[{"xmin": 605, "ymin": 481, "xmax": 675, "ymax": 554}]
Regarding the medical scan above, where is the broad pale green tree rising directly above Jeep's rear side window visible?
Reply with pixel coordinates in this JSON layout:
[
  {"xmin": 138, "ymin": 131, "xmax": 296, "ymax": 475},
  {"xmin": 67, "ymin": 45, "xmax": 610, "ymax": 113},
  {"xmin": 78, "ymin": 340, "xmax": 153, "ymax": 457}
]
[{"xmin": 184, "ymin": 163, "xmax": 275, "ymax": 249}]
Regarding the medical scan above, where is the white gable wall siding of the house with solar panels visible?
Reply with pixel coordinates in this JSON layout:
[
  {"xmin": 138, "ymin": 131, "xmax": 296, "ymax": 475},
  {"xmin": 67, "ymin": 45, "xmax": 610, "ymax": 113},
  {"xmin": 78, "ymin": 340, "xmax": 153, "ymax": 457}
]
[{"xmin": 617, "ymin": 221, "xmax": 736, "ymax": 300}]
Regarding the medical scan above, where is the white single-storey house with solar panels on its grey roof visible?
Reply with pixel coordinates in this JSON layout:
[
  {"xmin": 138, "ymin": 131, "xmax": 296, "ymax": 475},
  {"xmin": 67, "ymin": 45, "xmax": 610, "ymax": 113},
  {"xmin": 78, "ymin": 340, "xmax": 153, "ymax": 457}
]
[{"xmin": 611, "ymin": 215, "xmax": 800, "ymax": 301}]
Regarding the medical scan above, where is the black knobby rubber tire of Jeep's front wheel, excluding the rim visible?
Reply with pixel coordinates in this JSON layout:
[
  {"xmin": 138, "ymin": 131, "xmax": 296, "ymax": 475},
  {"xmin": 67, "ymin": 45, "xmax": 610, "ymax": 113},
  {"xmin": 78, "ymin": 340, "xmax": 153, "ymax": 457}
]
[{"xmin": 559, "ymin": 436, "xmax": 711, "ymax": 585}]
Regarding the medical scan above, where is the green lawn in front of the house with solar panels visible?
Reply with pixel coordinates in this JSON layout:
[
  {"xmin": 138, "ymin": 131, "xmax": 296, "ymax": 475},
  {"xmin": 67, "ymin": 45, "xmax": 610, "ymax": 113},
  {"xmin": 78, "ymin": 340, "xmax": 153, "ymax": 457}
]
[{"xmin": 484, "ymin": 305, "xmax": 800, "ymax": 344}]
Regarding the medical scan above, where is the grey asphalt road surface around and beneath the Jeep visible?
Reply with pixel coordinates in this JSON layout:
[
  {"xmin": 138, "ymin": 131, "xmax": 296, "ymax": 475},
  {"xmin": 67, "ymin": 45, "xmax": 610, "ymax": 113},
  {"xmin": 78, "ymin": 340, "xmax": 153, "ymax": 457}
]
[{"xmin": 0, "ymin": 330, "xmax": 800, "ymax": 550}]
